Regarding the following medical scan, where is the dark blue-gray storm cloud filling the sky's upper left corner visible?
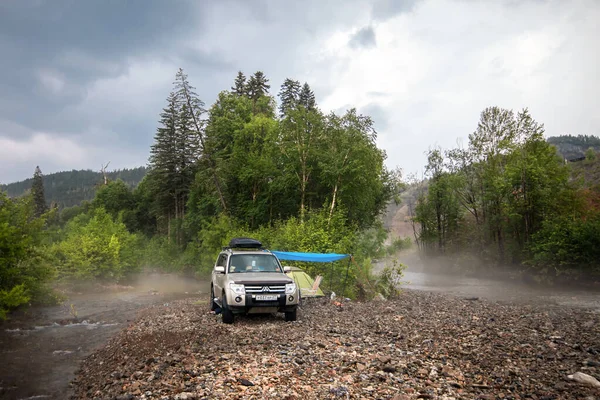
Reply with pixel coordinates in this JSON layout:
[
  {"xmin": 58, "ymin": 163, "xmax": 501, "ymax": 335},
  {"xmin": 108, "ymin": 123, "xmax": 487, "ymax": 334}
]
[{"xmin": 0, "ymin": 0, "xmax": 201, "ymax": 135}]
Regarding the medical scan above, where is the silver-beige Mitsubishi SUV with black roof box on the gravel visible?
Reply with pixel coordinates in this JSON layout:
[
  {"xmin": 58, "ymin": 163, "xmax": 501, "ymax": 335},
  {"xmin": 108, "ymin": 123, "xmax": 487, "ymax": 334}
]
[{"xmin": 210, "ymin": 238, "xmax": 300, "ymax": 324}]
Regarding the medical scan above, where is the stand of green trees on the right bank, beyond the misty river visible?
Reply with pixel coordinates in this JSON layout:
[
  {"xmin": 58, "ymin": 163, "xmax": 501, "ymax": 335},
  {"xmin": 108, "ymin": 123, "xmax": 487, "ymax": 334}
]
[{"xmin": 414, "ymin": 107, "xmax": 600, "ymax": 281}]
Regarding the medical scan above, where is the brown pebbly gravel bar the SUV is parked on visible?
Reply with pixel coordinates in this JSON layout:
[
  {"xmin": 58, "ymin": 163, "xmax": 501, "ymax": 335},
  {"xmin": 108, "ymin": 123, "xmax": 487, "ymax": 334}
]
[{"xmin": 73, "ymin": 290, "xmax": 600, "ymax": 400}]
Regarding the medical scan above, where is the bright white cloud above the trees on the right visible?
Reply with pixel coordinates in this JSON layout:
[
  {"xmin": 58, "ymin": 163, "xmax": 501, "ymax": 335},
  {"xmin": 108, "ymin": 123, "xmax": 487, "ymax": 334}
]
[{"xmin": 319, "ymin": 1, "xmax": 600, "ymax": 176}]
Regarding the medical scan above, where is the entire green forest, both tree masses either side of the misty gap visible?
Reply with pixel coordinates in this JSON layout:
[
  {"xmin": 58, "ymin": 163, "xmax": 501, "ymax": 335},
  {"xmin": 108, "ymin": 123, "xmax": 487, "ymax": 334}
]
[{"xmin": 0, "ymin": 69, "xmax": 600, "ymax": 317}]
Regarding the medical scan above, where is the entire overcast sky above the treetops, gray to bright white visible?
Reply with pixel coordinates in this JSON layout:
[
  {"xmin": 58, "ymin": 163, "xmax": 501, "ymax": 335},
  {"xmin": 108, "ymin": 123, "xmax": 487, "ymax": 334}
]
[{"xmin": 0, "ymin": 0, "xmax": 600, "ymax": 183}]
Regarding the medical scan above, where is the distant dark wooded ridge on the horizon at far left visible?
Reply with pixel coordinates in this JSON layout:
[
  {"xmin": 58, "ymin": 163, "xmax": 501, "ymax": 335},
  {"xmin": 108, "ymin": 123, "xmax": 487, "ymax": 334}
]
[{"xmin": 0, "ymin": 167, "xmax": 147, "ymax": 208}]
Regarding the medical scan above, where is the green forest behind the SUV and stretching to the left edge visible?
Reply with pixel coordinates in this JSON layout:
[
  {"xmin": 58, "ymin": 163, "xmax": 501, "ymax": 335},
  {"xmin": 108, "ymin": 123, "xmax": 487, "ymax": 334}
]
[{"xmin": 0, "ymin": 70, "xmax": 402, "ymax": 316}]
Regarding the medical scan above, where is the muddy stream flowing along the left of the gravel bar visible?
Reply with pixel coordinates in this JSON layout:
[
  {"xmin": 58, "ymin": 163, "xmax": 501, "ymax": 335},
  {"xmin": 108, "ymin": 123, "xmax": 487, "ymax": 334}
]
[{"xmin": 0, "ymin": 275, "xmax": 208, "ymax": 399}]
